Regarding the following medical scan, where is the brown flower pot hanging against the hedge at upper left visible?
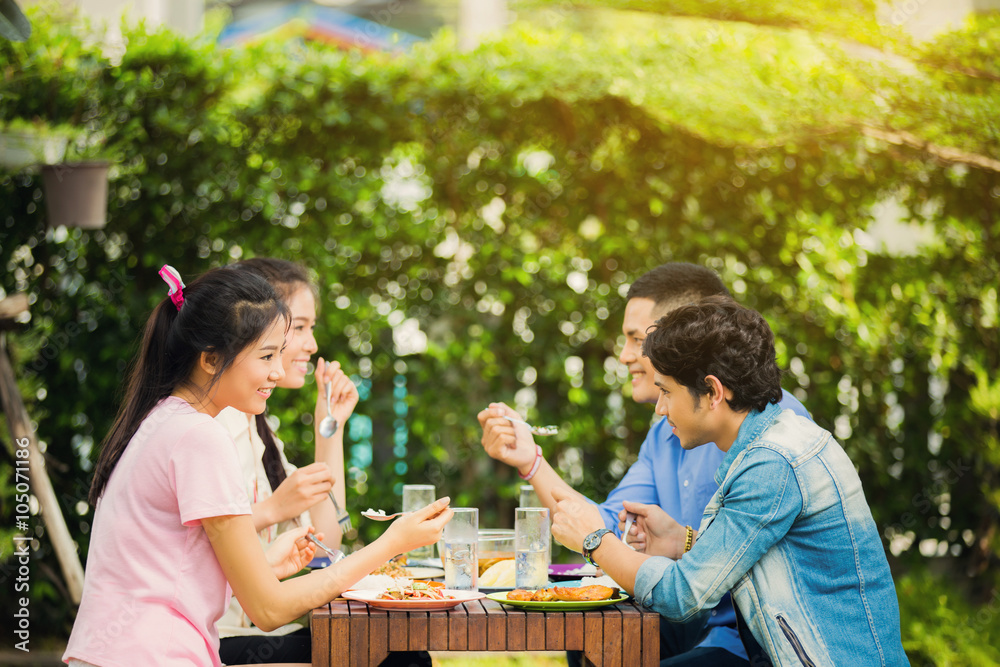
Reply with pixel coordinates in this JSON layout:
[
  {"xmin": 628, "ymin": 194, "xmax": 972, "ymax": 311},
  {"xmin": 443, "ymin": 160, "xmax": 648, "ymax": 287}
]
[{"xmin": 42, "ymin": 162, "xmax": 110, "ymax": 229}]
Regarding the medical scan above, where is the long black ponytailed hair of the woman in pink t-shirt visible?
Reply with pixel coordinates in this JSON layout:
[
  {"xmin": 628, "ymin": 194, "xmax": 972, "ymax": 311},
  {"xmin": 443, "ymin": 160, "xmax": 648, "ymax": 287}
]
[{"xmin": 89, "ymin": 269, "xmax": 289, "ymax": 505}]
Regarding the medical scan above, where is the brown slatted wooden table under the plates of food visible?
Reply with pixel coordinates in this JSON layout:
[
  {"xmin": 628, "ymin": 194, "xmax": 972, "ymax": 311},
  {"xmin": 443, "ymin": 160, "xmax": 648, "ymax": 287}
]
[{"xmin": 310, "ymin": 599, "xmax": 660, "ymax": 667}]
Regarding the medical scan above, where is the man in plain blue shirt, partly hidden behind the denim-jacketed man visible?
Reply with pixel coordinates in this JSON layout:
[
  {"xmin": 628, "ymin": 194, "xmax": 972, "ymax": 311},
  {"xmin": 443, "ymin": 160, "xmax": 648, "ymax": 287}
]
[{"xmin": 479, "ymin": 262, "xmax": 808, "ymax": 667}]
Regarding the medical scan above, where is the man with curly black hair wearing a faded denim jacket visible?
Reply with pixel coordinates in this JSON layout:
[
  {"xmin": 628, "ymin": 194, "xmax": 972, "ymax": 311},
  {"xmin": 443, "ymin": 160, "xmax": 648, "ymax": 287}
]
[{"xmin": 552, "ymin": 297, "xmax": 909, "ymax": 666}]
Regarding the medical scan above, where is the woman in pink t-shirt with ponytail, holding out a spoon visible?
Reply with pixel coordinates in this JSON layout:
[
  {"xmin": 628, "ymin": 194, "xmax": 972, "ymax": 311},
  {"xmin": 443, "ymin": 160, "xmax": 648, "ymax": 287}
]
[{"xmin": 63, "ymin": 267, "xmax": 452, "ymax": 667}]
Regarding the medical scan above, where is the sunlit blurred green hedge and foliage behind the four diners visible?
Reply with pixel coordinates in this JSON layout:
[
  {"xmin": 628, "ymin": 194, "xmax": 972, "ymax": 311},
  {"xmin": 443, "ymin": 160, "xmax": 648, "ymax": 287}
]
[{"xmin": 0, "ymin": 1, "xmax": 1000, "ymax": 664}]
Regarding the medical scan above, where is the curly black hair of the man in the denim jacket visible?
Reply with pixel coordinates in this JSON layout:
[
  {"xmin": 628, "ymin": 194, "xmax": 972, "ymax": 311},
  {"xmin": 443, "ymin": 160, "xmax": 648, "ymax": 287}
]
[{"xmin": 642, "ymin": 296, "xmax": 781, "ymax": 412}]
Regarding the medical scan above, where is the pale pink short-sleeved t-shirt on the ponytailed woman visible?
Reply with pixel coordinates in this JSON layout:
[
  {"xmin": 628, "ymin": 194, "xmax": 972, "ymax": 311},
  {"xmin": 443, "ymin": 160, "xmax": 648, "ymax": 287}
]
[{"xmin": 63, "ymin": 397, "xmax": 250, "ymax": 667}]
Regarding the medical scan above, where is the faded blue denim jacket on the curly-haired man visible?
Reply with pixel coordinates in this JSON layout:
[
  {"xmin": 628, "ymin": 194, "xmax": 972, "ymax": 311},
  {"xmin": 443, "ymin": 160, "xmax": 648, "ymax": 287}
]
[{"xmin": 635, "ymin": 405, "xmax": 909, "ymax": 667}]
